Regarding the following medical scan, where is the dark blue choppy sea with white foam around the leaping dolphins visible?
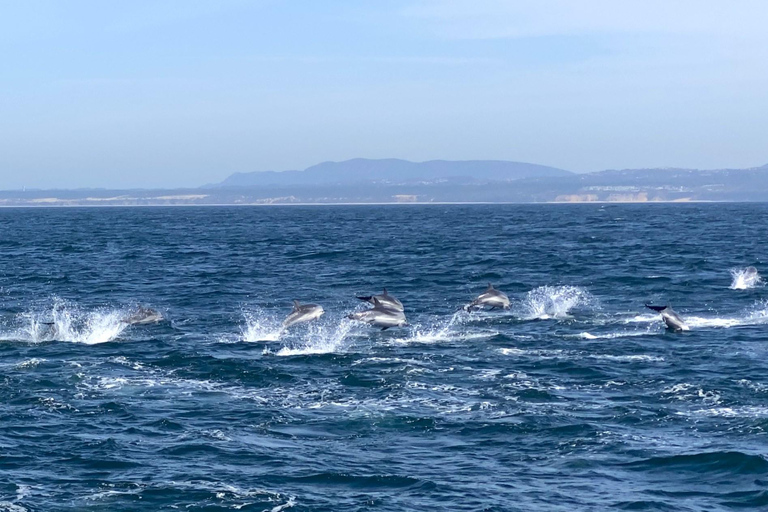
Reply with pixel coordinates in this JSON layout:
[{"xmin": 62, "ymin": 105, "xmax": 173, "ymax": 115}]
[{"xmin": 0, "ymin": 204, "xmax": 768, "ymax": 512}]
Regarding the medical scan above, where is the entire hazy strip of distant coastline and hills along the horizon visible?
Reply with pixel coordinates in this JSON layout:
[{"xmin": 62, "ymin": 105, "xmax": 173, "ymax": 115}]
[{"xmin": 0, "ymin": 158, "xmax": 768, "ymax": 206}]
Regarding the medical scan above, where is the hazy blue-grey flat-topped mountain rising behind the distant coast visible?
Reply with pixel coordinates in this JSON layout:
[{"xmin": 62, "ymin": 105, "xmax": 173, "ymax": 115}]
[{"xmin": 211, "ymin": 158, "xmax": 573, "ymax": 187}]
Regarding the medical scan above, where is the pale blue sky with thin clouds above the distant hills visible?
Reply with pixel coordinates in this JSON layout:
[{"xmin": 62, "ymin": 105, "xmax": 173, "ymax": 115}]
[{"xmin": 0, "ymin": 0, "xmax": 768, "ymax": 189}]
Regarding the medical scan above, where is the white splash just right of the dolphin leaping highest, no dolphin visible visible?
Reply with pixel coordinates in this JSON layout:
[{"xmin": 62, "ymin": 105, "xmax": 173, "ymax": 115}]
[{"xmin": 517, "ymin": 286, "xmax": 597, "ymax": 320}]
